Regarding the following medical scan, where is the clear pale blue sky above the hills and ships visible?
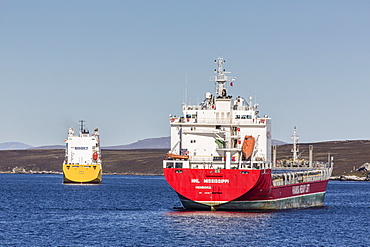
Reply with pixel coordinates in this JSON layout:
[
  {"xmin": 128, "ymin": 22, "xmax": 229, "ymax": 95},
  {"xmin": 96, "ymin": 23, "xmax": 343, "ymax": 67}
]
[{"xmin": 0, "ymin": 0, "xmax": 370, "ymax": 146}]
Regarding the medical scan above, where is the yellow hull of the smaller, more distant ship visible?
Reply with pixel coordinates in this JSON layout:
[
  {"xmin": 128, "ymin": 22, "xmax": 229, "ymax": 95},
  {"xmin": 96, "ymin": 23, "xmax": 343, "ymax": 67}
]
[{"xmin": 63, "ymin": 164, "xmax": 102, "ymax": 183}]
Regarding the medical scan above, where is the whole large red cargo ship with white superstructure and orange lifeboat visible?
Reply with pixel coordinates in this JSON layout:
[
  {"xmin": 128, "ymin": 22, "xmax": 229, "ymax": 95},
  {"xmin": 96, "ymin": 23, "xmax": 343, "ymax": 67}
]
[{"xmin": 163, "ymin": 58, "xmax": 333, "ymax": 210}]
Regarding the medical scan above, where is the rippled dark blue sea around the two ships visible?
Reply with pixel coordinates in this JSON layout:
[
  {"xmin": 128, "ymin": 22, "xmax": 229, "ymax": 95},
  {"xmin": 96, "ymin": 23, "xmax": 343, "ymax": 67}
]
[{"xmin": 0, "ymin": 174, "xmax": 370, "ymax": 246}]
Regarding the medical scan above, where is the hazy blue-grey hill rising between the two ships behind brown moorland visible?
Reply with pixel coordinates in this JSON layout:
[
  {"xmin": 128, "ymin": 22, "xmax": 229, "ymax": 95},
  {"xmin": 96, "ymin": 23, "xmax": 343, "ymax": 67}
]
[{"xmin": 103, "ymin": 137, "xmax": 171, "ymax": 149}]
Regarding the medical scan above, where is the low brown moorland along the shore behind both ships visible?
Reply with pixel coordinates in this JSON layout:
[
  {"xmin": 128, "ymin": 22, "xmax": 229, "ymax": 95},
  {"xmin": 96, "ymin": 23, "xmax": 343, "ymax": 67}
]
[{"xmin": 0, "ymin": 138, "xmax": 370, "ymax": 176}]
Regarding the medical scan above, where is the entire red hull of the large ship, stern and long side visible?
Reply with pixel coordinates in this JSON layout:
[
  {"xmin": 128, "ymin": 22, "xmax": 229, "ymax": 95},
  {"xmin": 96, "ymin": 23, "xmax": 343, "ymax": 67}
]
[{"xmin": 164, "ymin": 168, "xmax": 328, "ymax": 210}]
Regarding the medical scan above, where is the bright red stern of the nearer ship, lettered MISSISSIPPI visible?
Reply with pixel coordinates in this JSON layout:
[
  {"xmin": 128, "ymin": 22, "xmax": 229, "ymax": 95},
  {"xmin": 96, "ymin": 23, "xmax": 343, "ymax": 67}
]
[{"xmin": 163, "ymin": 168, "xmax": 261, "ymax": 210}]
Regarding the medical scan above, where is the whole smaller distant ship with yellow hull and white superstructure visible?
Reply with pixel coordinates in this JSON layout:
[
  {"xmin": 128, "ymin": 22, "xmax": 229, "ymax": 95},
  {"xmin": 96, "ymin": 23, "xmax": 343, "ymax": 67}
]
[{"xmin": 63, "ymin": 120, "xmax": 102, "ymax": 183}]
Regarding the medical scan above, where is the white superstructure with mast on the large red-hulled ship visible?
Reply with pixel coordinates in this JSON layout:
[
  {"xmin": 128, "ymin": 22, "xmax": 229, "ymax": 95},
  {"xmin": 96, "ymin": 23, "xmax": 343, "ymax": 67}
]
[{"xmin": 163, "ymin": 57, "xmax": 271, "ymax": 169}]
